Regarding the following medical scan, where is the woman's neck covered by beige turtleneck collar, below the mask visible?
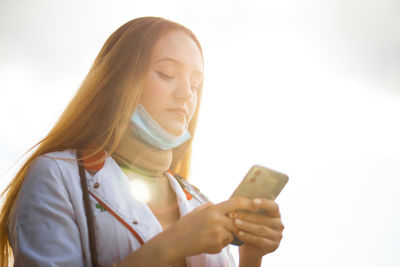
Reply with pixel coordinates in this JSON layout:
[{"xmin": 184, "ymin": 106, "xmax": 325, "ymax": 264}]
[{"xmin": 112, "ymin": 125, "xmax": 172, "ymax": 176}]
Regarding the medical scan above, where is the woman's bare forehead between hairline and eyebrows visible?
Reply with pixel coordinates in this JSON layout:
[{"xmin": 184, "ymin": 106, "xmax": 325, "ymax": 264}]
[{"xmin": 151, "ymin": 30, "xmax": 203, "ymax": 73}]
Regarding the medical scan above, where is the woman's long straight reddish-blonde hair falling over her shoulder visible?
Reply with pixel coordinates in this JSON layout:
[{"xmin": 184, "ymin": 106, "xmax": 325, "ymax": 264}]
[{"xmin": 0, "ymin": 17, "xmax": 203, "ymax": 267}]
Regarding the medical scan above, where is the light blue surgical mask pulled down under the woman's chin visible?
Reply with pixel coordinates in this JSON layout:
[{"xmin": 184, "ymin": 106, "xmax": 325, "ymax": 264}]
[{"xmin": 131, "ymin": 104, "xmax": 191, "ymax": 150}]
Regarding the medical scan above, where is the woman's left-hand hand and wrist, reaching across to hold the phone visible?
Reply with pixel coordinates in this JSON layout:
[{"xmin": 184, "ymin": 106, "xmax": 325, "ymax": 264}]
[{"xmin": 141, "ymin": 197, "xmax": 258, "ymax": 265}]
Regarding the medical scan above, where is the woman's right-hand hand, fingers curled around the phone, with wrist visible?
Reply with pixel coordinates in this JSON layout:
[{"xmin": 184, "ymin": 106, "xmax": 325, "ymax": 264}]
[{"xmin": 229, "ymin": 199, "xmax": 284, "ymax": 266}]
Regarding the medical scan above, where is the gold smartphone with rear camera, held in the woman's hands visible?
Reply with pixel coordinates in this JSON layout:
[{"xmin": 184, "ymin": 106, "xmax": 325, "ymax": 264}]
[{"xmin": 231, "ymin": 165, "xmax": 289, "ymax": 246}]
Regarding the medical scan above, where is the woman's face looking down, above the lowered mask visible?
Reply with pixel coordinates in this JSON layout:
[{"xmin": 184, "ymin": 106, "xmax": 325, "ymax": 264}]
[{"xmin": 141, "ymin": 30, "xmax": 203, "ymax": 135}]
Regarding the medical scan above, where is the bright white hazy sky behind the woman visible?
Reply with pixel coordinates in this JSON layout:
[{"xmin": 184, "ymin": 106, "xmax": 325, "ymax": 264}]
[{"xmin": 0, "ymin": 0, "xmax": 400, "ymax": 267}]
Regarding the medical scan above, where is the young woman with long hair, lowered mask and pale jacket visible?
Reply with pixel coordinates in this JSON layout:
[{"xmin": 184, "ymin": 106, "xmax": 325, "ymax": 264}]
[{"xmin": 0, "ymin": 17, "xmax": 283, "ymax": 267}]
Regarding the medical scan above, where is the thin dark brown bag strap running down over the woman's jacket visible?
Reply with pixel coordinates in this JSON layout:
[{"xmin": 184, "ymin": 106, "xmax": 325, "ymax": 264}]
[{"xmin": 76, "ymin": 150, "xmax": 99, "ymax": 267}]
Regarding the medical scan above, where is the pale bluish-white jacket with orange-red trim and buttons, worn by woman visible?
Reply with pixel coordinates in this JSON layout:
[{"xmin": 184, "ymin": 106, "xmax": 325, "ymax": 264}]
[{"xmin": 8, "ymin": 149, "xmax": 235, "ymax": 267}]
